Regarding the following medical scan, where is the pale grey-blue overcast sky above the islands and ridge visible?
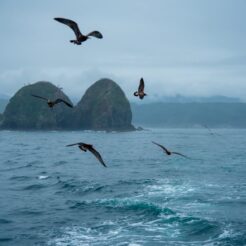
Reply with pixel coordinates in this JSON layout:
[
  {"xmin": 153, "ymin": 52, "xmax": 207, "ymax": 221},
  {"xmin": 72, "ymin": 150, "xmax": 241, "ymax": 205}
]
[{"xmin": 0, "ymin": 0, "xmax": 246, "ymax": 101}]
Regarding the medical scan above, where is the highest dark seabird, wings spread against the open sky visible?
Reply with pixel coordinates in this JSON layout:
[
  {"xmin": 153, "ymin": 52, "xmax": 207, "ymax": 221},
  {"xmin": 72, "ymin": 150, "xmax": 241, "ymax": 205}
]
[{"xmin": 54, "ymin": 18, "xmax": 103, "ymax": 45}]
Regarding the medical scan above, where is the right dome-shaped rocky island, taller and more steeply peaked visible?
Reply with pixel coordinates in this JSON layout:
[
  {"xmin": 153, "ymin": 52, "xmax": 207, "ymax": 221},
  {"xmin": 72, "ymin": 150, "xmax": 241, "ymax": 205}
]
[{"xmin": 75, "ymin": 79, "xmax": 134, "ymax": 131}]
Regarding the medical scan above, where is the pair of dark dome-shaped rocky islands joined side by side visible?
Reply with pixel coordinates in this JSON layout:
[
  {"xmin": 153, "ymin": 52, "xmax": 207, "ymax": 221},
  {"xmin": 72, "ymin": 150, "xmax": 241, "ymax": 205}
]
[{"xmin": 0, "ymin": 79, "xmax": 135, "ymax": 131}]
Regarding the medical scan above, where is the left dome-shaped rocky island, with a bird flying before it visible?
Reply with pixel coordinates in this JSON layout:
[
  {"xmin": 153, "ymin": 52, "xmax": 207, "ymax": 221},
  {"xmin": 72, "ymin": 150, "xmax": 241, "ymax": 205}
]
[{"xmin": 2, "ymin": 82, "xmax": 73, "ymax": 129}]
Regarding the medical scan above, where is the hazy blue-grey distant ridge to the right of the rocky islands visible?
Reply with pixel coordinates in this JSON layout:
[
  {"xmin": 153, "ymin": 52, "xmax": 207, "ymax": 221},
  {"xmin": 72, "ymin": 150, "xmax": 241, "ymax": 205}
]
[{"xmin": 131, "ymin": 103, "xmax": 246, "ymax": 128}]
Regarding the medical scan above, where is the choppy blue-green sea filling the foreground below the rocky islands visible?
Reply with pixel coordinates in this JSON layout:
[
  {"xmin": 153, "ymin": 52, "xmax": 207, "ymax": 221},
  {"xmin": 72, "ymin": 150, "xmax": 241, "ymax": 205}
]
[{"xmin": 0, "ymin": 129, "xmax": 246, "ymax": 246}]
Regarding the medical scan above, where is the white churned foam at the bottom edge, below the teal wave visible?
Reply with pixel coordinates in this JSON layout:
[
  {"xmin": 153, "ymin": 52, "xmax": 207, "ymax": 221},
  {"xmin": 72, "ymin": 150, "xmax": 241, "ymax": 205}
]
[{"xmin": 48, "ymin": 217, "xmax": 184, "ymax": 246}]
